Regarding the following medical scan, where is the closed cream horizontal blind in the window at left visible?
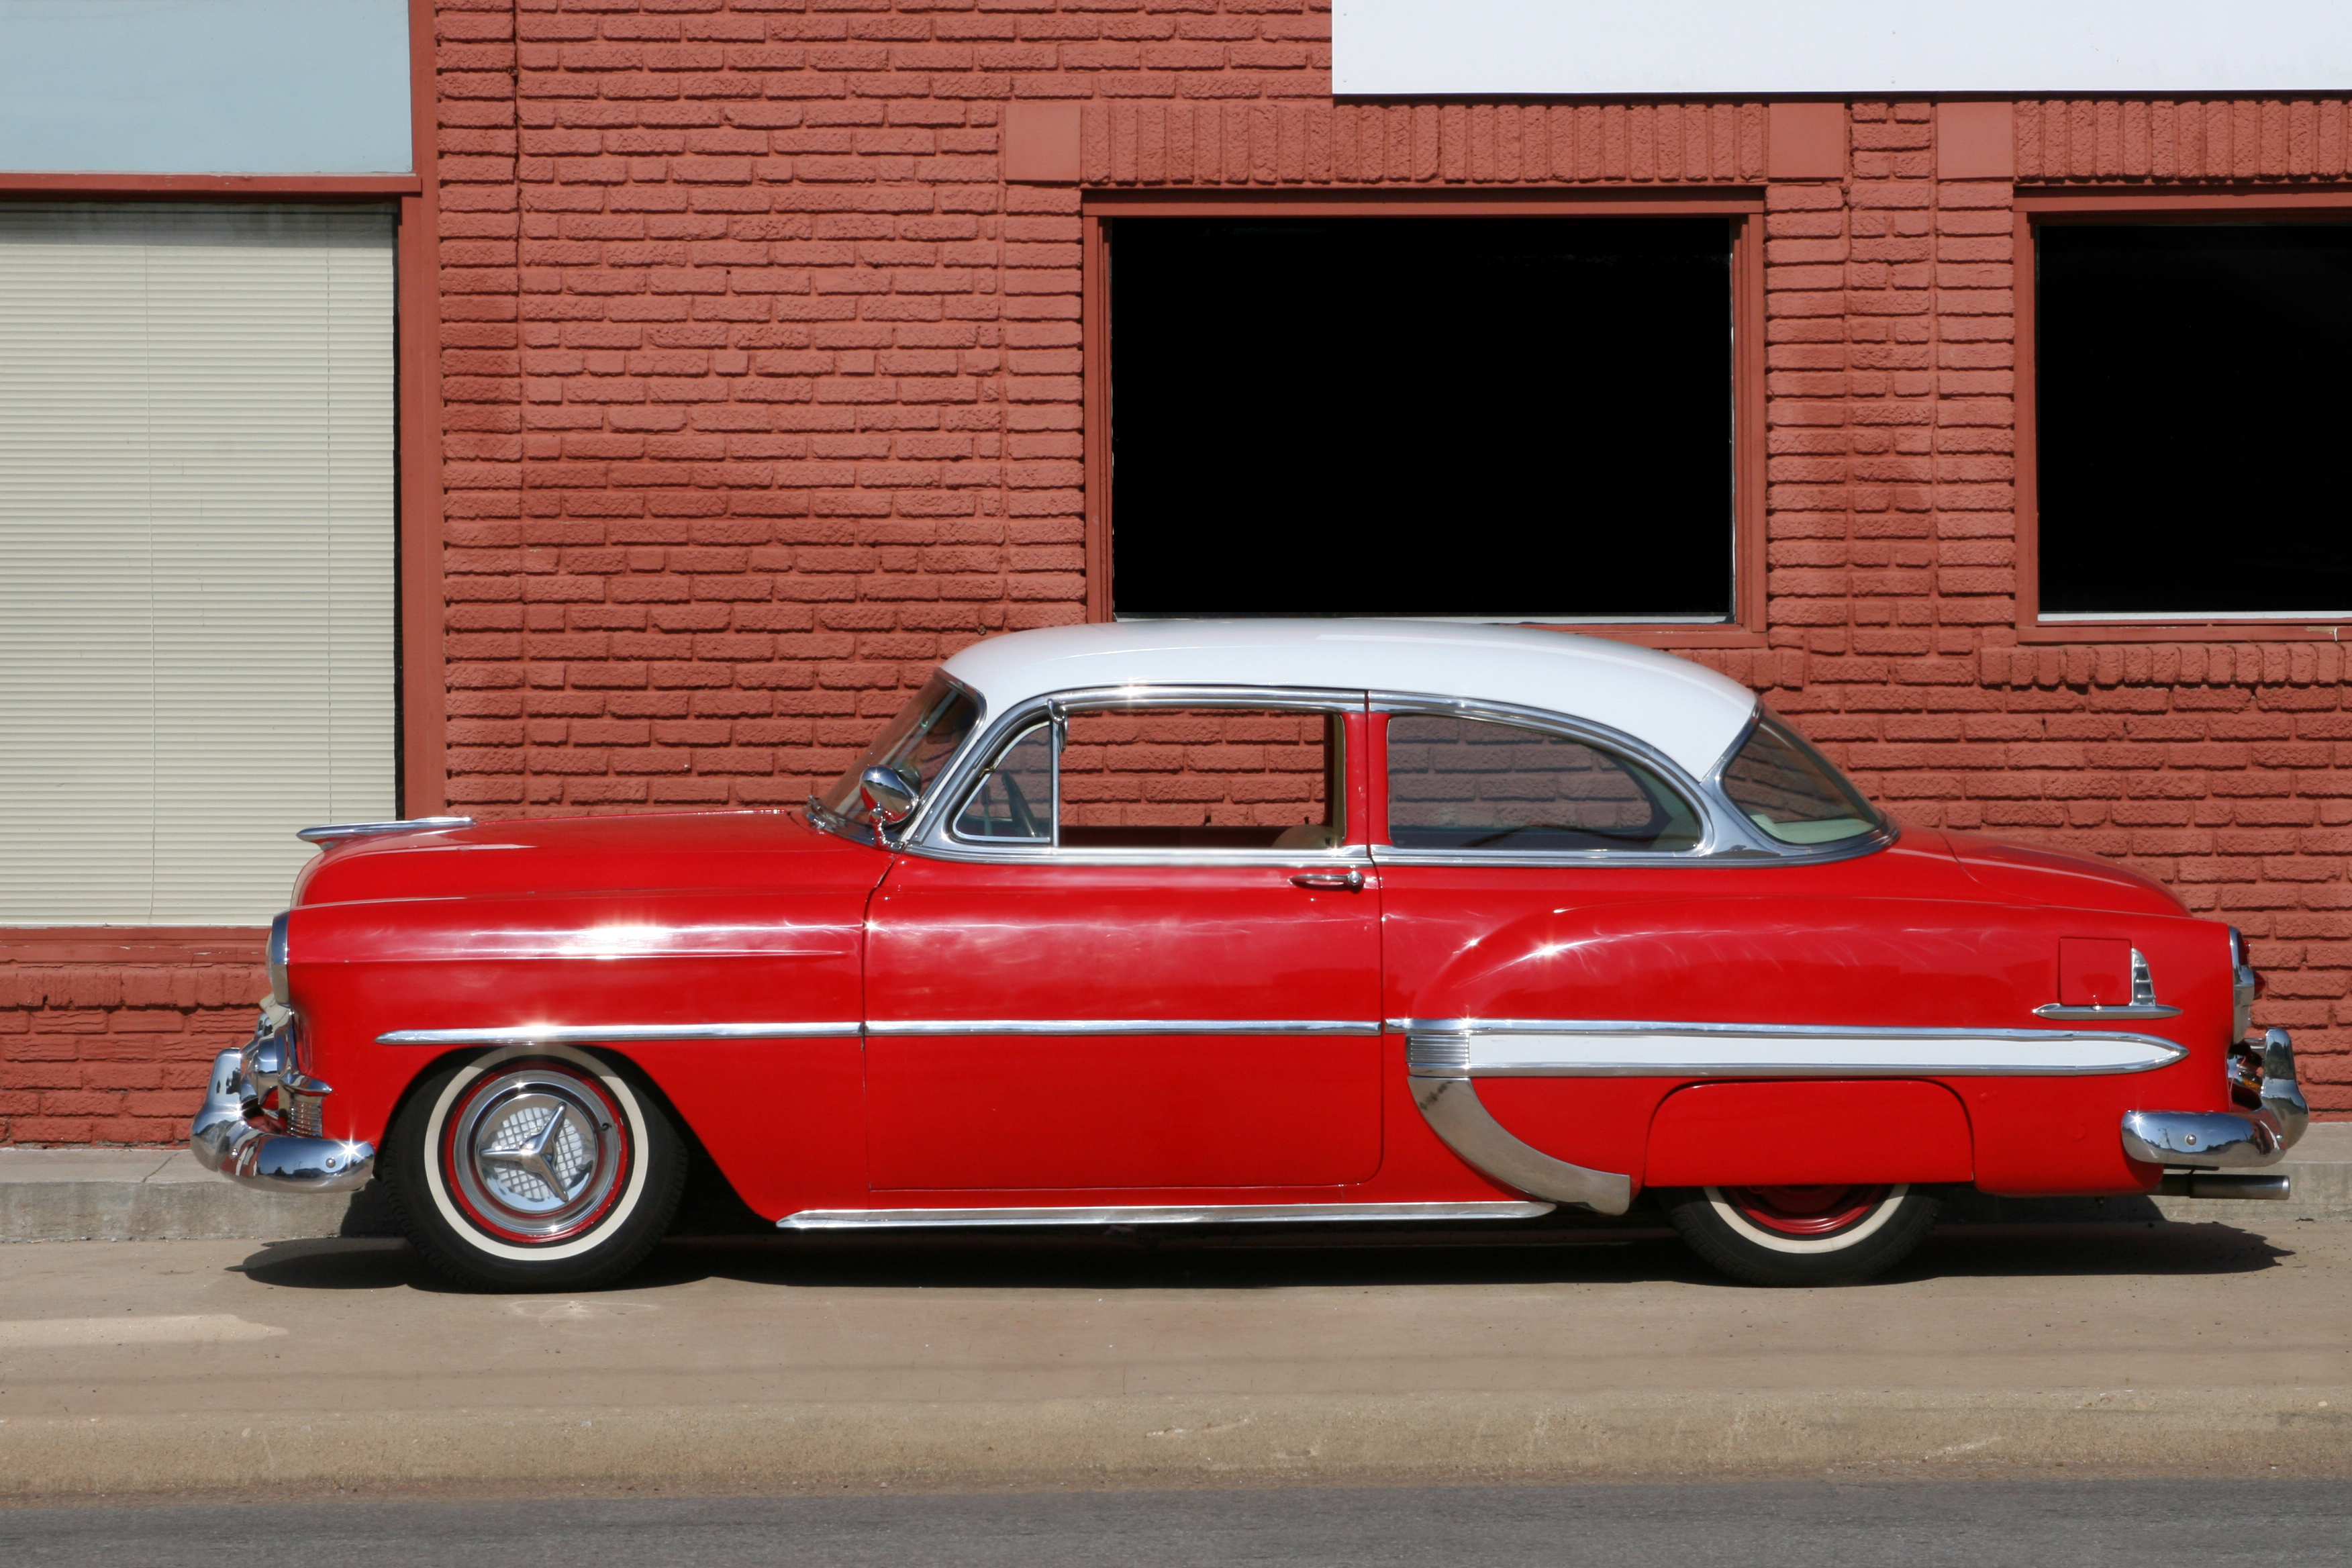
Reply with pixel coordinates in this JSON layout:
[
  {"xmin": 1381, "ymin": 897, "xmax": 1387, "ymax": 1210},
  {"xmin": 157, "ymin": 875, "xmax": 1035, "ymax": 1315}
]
[{"xmin": 0, "ymin": 202, "xmax": 395, "ymax": 926}]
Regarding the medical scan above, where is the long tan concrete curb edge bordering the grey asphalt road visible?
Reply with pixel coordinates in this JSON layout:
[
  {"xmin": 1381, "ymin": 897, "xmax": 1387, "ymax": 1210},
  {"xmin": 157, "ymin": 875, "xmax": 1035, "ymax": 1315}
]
[{"xmin": 0, "ymin": 1387, "xmax": 2352, "ymax": 1502}]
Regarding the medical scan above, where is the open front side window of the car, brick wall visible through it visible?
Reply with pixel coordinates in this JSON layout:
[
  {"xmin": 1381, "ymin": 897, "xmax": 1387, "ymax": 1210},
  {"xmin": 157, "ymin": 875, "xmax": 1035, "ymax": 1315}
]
[{"xmin": 1059, "ymin": 707, "xmax": 1345, "ymax": 848}]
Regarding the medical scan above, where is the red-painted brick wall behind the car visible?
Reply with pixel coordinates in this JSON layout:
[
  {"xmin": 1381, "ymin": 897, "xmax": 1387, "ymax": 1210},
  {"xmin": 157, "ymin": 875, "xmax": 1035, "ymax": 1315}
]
[{"xmin": 0, "ymin": 0, "xmax": 2352, "ymax": 1140}]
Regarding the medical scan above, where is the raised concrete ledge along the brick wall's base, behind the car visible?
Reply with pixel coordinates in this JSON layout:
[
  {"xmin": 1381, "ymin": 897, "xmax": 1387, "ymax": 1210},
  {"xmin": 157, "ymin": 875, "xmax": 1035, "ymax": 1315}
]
[{"xmin": 0, "ymin": 1122, "xmax": 2352, "ymax": 1241}]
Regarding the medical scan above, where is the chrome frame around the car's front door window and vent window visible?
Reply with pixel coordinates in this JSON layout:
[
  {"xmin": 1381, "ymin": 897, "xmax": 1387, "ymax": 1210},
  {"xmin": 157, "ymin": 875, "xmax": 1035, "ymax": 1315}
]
[{"xmin": 896, "ymin": 682, "xmax": 1371, "ymax": 867}]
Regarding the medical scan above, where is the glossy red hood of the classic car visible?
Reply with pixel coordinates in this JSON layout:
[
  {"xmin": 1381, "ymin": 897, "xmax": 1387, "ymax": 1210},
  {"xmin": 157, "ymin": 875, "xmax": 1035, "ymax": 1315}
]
[{"xmin": 294, "ymin": 811, "xmax": 889, "ymax": 905}]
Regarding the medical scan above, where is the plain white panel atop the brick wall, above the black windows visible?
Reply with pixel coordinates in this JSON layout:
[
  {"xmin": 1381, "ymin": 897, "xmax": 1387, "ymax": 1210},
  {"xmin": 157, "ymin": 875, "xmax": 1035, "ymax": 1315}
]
[{"xmin": 1331, "ymin": 0, "xmax": 2352, "ymax": 97}]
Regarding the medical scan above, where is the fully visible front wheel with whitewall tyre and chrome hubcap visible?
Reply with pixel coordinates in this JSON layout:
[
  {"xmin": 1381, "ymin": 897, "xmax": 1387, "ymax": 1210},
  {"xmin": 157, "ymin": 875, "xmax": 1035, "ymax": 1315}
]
[{"xmin": 386, "ymin": 1046, "xmax": 687, "ymax": 1291}]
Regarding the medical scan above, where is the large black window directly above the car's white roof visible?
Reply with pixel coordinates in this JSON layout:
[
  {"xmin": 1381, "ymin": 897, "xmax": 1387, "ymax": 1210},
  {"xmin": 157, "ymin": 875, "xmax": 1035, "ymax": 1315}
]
[{"xmin": 1110, "ymin": 219, "xmax": 1733, "ymax": 621}]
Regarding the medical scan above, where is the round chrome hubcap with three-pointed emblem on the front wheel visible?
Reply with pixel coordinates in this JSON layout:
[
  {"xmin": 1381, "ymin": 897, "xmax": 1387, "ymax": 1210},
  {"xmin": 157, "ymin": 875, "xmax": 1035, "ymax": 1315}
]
[{"xmin": 449, "ymin": 1065, "xmax": 626, "ymax": 1239}]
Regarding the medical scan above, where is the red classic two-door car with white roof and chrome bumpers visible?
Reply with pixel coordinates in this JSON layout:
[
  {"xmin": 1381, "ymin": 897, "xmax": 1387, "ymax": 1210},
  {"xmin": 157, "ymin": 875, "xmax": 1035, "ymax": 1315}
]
[{"xmin": 193, "ymin": 621, "xmax": 2307, "ymax": 1288}]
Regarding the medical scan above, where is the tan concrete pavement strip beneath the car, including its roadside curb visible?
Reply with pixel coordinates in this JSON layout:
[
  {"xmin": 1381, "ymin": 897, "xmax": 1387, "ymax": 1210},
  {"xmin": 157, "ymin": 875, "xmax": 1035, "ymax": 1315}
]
[{"xmin": 0, "ymin": 1204, "xmax": 2352, "ymax": 1500}]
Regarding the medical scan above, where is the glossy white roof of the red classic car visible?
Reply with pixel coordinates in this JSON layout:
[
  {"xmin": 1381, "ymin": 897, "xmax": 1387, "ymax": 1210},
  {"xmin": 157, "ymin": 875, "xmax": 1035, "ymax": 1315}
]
[{"xmin": 943, "ymin": 621, "xmax": 1757, "ymax": 778}]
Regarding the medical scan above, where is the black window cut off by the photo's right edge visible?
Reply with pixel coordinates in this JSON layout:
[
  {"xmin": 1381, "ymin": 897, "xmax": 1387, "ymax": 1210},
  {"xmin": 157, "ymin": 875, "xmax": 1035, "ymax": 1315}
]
[{"xmin": 2035, "ymin": 224, "xmax": 2352, "ymax": 616}]
